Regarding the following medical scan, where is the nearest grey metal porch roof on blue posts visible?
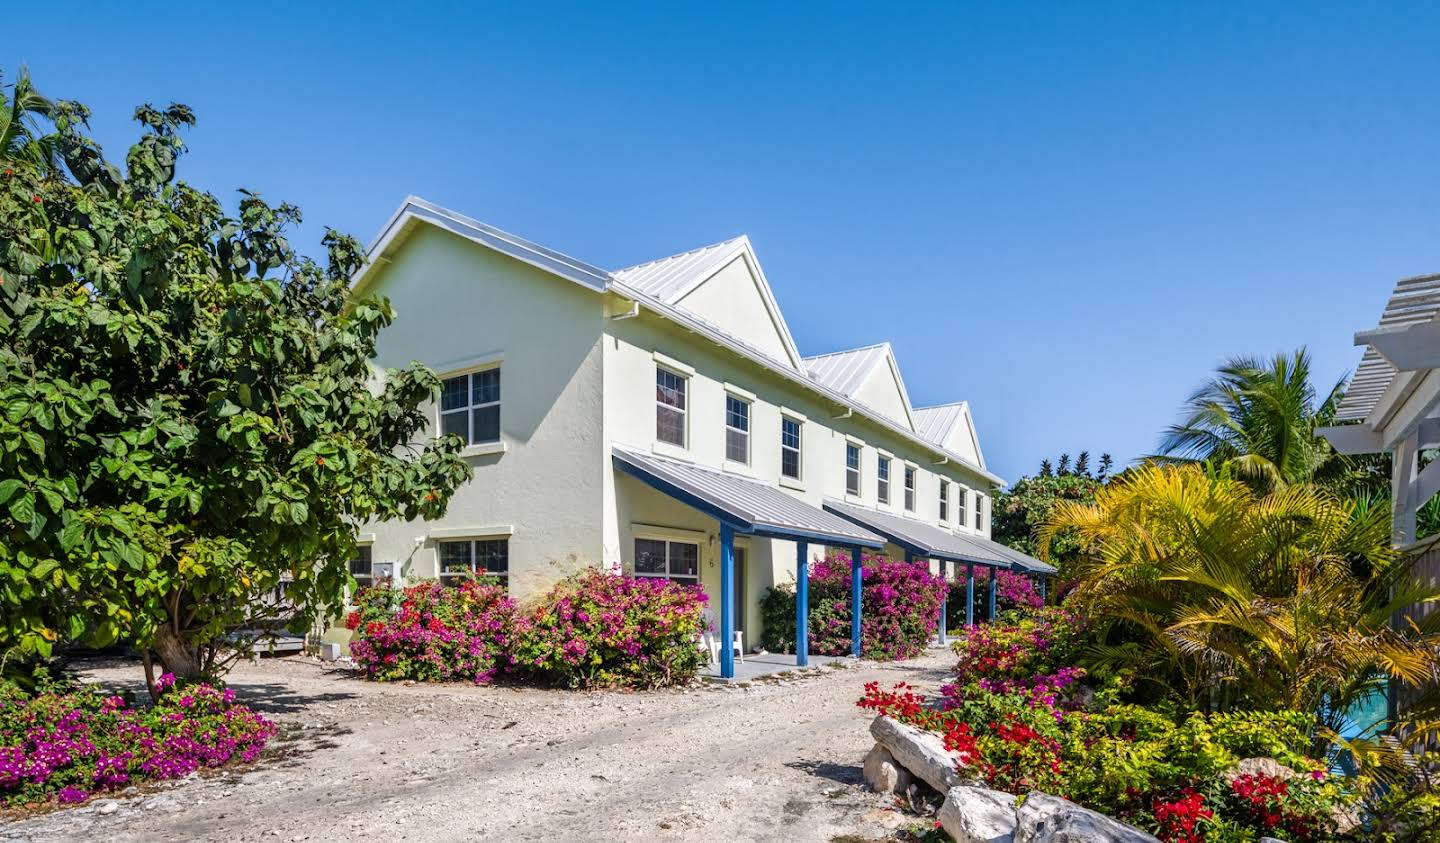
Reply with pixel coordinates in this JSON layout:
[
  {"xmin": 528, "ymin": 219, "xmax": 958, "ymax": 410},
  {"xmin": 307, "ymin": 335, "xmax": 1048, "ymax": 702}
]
[{"xmin": 611, "ymin": 445, "xmax": 886, "ymax": 548}]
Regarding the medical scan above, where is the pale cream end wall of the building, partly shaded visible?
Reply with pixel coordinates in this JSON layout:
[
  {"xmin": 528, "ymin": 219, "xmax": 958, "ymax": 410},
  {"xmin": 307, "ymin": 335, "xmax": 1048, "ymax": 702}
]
[{"xmin": 360, "ymin": 225, "xmax": 608, "ymax": 598}]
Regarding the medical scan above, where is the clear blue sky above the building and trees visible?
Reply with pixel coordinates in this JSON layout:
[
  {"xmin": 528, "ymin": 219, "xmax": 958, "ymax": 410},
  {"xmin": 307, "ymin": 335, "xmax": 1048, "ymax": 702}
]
[{"xmin": 11, "ymin": 3, "xmax": 1440, "ymax": 478}]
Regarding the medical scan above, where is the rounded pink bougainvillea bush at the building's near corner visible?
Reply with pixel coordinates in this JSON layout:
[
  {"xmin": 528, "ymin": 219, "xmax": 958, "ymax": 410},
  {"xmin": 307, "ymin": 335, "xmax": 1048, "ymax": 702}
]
[{"xmin": 516, "ymin": 569, "xmax": 708, "ymax": 689}]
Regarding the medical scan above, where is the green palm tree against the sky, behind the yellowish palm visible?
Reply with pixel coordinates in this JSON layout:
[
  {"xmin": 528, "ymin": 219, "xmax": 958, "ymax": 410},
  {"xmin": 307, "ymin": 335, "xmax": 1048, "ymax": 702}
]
[{"xmin": 1151, "ymin": 347, "xmax": 1351, "ymax": 491}]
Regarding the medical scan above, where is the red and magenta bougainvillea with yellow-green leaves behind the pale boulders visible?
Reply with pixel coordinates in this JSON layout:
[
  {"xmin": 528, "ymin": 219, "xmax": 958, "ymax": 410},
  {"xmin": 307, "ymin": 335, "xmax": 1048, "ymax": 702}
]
[{"xmin": 858, "ymin": 610, "xmax": 1364, "ymax": 843}]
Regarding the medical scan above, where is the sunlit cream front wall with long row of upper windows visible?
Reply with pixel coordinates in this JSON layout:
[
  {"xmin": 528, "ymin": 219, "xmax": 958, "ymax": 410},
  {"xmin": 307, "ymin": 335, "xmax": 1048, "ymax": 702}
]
[{"xmin": 603, "ymin": 302, "xmax": 985, "ymax": 640}]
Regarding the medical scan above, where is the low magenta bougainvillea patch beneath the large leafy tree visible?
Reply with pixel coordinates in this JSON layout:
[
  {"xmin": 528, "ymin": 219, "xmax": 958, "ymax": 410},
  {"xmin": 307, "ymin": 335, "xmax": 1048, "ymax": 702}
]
[{"xmin": 0, "ymin": 674, "xmax": 275, "ymax": 806}]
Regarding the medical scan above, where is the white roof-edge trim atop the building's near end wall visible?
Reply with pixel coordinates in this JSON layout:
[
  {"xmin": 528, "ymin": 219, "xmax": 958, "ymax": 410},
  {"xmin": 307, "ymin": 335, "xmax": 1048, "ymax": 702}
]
[{"xmin": 350, "ymin": 196, "xmax": 611, "ymax": 299}]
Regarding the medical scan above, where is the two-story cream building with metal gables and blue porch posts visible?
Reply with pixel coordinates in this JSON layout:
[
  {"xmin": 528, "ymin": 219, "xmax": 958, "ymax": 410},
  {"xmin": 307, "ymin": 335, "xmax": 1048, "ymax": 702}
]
[{"xmin": 344, "ymin": 197, "xmax": 1045, "ymax": 670}]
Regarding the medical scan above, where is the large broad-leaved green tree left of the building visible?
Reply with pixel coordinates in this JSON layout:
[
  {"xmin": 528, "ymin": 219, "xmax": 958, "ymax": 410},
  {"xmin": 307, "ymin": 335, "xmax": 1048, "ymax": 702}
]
[{"xmin": 0, "ymin": 73, "xmax": 469, "ymax": 691}]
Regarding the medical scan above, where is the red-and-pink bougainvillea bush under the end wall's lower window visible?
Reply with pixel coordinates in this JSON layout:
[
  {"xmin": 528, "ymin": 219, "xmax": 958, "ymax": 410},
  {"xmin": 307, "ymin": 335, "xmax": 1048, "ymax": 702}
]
[{"xmin": 346, "ymin": 579, "xmax": 524, "ymax": 684}]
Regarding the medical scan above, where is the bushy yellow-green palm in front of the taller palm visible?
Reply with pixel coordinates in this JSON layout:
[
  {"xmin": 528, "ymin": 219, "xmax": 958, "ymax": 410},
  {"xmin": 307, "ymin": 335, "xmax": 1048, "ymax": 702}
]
[{"xmin": 1038, "ymin": 464, "xmax": 1440, "ymax": 729}]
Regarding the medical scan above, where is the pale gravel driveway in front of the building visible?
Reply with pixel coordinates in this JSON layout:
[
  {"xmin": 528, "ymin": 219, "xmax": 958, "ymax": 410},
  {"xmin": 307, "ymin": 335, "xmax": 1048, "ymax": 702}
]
[{"xmin": 0, "ymin": 651, "xmax": 953, "ymax": 843}]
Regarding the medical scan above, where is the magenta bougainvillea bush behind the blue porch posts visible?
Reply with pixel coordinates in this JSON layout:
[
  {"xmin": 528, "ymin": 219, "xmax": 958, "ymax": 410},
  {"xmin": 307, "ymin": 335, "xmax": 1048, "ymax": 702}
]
[{"xmin": 760, "ymin": 553, "xmax": 945, "ymax": 660}]
